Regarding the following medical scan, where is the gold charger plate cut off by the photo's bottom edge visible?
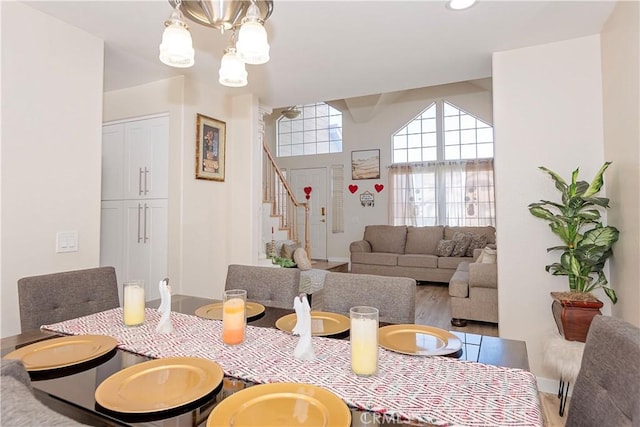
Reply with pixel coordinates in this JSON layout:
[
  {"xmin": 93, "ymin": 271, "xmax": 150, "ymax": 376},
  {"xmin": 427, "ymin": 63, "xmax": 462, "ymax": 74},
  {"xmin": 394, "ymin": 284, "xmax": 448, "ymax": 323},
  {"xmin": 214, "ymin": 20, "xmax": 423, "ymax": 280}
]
[{"xmin": 207, "ymin": 383, "xmax": 351, "ymax": 427}]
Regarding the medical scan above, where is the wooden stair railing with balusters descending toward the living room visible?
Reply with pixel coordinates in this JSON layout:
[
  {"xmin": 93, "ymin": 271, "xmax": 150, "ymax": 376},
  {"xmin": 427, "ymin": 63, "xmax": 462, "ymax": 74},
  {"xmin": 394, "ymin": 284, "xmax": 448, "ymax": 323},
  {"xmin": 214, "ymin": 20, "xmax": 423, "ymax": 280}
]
[{"xmin": 262, "ymin": 136, "xmax": 311, "ymax": 259}]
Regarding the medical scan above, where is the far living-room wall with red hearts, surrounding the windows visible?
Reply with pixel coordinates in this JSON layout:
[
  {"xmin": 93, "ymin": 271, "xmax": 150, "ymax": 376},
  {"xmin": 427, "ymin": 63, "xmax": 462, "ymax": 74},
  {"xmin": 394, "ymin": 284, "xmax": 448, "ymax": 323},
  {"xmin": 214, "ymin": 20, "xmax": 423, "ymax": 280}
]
[{"xmin": 267, "ymin": 82, "xmax": 493, "ymax": 261}]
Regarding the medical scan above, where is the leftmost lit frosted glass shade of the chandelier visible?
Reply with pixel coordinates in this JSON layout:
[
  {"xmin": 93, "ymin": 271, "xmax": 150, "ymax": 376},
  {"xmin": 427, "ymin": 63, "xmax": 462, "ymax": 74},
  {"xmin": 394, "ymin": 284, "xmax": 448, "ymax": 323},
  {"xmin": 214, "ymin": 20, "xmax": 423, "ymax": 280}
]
[{"xmin": 159, "ymin": 9, "xmax": 195, "ymax": 68}]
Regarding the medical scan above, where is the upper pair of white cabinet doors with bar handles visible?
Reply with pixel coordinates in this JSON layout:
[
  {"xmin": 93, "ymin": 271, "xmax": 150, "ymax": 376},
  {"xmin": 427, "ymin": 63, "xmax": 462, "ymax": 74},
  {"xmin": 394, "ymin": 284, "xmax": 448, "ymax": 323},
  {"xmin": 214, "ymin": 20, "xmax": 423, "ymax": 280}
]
[{"xmin": 102, "ymin": 117, "xmax": 169, "ymax": 200}]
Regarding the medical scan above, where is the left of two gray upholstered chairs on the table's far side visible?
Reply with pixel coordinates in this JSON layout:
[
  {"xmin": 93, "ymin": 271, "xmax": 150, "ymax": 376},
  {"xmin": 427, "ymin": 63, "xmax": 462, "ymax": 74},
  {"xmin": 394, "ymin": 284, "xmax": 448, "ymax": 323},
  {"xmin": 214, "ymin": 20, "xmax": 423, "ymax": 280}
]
[{"xmin": 225, "ymin": 264, "xmax": 300, "ymax": 308}]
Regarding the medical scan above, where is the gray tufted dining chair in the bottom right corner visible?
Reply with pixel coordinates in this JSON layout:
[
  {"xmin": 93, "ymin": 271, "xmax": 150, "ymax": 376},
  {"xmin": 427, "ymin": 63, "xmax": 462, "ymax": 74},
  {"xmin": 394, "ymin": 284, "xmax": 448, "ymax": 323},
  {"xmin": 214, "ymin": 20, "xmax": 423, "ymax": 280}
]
[{"xmin": 565, "ymin": 316, "xmax": 640, "ymax": 427}]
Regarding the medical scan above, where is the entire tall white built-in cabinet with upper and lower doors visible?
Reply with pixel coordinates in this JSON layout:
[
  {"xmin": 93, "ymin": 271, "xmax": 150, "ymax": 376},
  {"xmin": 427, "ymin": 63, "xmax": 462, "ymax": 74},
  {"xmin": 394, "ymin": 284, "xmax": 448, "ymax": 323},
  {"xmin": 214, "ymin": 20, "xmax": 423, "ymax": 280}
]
[{"xmin": 100, "ymin": 117, "xmax": 169, "ymax": 301}]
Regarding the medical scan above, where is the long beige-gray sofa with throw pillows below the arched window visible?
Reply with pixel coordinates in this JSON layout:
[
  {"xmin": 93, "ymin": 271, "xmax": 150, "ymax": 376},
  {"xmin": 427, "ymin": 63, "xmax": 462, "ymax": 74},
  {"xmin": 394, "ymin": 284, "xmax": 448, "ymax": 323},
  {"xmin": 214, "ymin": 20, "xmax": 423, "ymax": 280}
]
[{"xmin": 349, "ymin": 225, "xmax": 496, "ymax": 283}]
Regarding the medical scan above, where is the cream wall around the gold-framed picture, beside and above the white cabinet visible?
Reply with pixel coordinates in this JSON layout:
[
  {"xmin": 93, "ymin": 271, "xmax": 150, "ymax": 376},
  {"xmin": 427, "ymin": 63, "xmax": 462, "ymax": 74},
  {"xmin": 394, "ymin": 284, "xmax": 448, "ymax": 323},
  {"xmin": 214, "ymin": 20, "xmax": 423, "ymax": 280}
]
[{"xmin": 104, "ymin": 77, "xmax": 261, "ymax": 304}]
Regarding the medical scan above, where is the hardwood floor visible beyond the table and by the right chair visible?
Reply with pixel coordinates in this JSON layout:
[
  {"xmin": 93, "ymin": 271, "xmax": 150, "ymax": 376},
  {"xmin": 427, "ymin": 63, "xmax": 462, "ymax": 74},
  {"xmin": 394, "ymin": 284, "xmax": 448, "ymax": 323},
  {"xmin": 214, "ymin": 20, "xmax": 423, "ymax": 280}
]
[{"xmin": 416, "ymin": 282, "xmax": 571, "ymax": 427}]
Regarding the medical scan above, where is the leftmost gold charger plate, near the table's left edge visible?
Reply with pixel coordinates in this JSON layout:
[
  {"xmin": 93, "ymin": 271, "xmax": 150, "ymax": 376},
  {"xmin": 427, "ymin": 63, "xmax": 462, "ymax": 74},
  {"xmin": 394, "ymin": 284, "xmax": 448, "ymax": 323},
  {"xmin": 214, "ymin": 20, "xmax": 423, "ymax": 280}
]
[{"xmin": 5, "ymin": 335, "xmax": 118, "ymax": 372}]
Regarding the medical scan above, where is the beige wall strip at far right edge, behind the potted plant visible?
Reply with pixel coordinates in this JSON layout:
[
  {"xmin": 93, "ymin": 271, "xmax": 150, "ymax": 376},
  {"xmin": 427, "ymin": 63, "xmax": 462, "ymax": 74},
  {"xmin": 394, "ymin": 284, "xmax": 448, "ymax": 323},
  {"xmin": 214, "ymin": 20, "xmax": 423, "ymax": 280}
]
[{"xmin": 602, "ymin": 2, "xmax": 640, "ymax": 326}]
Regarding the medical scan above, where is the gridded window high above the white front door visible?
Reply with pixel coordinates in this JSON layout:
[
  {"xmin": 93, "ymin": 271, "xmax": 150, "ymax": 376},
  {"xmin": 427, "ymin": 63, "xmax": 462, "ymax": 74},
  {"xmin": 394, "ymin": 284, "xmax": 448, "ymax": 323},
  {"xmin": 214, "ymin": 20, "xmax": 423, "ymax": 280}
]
[{"xmin": 276, "ymin": 102, "xmax": 342, "ymax": 157}]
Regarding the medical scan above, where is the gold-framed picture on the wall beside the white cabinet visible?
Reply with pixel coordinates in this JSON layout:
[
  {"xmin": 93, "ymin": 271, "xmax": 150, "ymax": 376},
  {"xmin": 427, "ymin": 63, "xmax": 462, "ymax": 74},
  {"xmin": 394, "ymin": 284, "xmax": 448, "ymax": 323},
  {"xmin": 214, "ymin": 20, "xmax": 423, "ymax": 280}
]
[{"xmin": 196, "ymin": 114, "xmax": 227, "ymax": 181}]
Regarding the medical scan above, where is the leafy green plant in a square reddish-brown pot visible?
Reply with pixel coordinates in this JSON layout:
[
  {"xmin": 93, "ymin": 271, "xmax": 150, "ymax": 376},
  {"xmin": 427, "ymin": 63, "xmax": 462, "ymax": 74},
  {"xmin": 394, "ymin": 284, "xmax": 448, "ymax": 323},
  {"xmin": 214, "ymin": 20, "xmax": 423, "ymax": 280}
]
[{"xmin": 529, "ymin": 162, "xmax": 619, "ymax": 342}]
